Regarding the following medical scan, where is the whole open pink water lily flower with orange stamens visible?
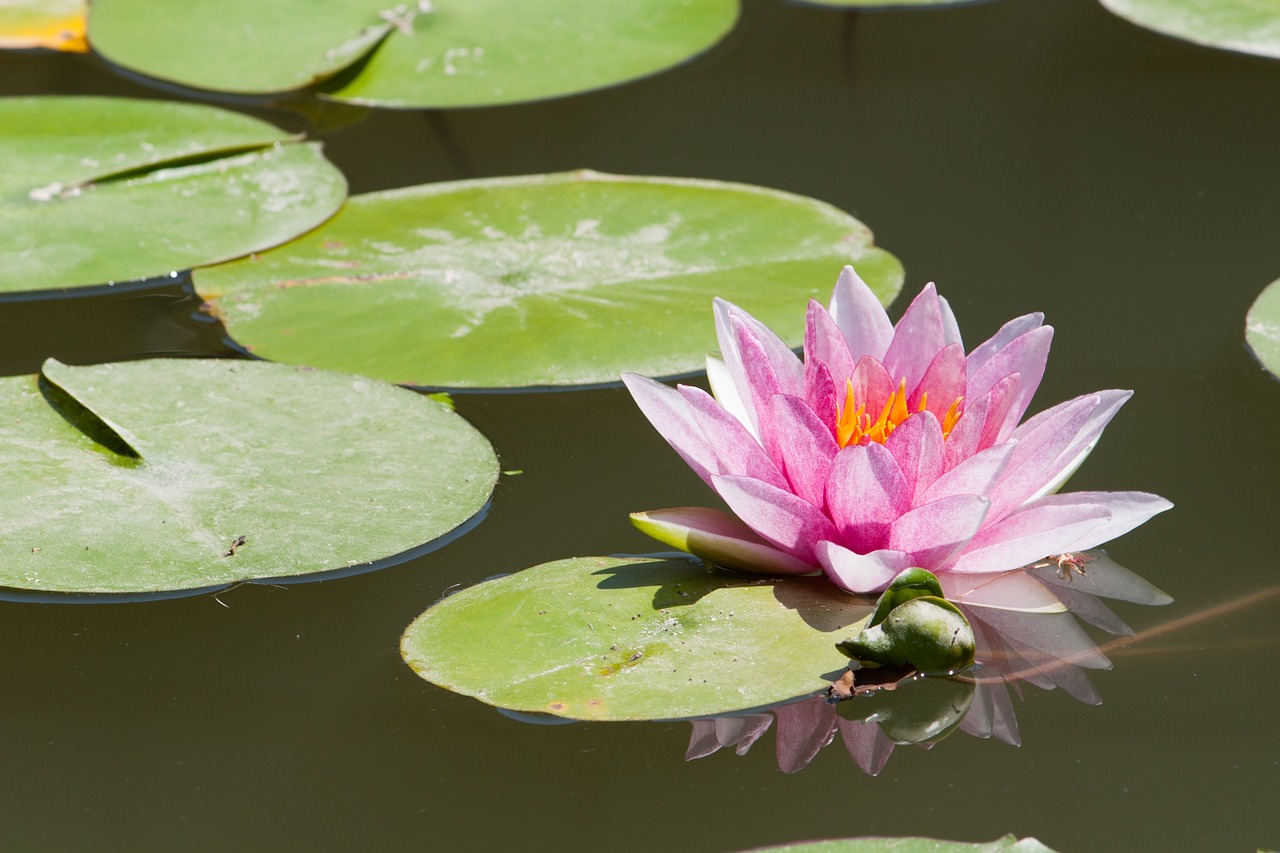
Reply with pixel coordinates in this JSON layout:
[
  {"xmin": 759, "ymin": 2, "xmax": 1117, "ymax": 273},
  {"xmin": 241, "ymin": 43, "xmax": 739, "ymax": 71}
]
[{"xmin": 623, "ymin": 266, "xmax": 1171, "ymax": 611}]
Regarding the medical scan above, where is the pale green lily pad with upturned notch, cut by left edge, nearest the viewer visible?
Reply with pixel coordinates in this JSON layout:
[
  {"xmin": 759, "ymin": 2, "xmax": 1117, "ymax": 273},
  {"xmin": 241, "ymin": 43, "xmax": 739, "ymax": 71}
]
[{"xmin": 0, "ymin": 359, "xmax": 498, "ymax": 593}]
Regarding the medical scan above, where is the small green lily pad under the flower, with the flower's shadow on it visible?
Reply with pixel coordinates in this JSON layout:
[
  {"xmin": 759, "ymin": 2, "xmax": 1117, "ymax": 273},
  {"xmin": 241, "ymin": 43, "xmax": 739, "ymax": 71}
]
[{"xmin": 401, "ymin": 557, "xmax": 872, "ymax": 720}]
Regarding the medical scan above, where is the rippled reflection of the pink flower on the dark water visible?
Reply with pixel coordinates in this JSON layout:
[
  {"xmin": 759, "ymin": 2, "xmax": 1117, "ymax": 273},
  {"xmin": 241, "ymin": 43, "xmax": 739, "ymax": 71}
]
[{"xmin": 685, "ymin": 552, "xmax": 1171, "ymax": 776}]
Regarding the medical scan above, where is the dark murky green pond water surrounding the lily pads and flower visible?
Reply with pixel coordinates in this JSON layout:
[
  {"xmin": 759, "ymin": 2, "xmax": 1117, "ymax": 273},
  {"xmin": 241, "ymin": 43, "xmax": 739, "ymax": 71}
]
[{"xmin": 0, "ymin": 0, "xmax": 1280, "ymax": 850}]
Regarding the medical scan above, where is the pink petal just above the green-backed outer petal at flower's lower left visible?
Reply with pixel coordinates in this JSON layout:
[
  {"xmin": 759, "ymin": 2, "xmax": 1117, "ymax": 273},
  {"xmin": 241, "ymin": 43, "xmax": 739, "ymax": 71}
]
[{"xmin": 712, "ymin": 476, "xmax": 837, "ymax": 566}]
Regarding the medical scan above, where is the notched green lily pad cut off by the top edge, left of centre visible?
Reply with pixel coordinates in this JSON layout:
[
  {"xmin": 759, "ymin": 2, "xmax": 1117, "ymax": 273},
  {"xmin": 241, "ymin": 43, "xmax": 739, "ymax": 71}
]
[{"xmin": 88, "ymin": 0, "xmax": 739, "ymax": 108}]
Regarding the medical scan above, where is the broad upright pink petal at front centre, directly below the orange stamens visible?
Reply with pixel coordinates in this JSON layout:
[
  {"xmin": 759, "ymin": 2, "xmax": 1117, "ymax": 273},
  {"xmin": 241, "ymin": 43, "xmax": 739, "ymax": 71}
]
[{"xmin": 827, "ymin": 442, "xmax": 911, "ymax": 553}]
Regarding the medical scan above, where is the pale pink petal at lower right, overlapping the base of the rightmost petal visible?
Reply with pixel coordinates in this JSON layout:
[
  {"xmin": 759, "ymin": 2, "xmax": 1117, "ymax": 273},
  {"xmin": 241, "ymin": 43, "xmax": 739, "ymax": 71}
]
[{"xmin": 951, "ymin": 503, "xmax": 1111, "ymax": 574}]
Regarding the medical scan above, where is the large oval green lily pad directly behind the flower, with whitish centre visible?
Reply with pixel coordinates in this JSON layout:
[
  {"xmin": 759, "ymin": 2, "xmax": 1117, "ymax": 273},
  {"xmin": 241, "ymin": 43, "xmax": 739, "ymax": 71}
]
[{"xmin": 195, "ymin": 172, "xmax": 902, "ymax": 388}]
